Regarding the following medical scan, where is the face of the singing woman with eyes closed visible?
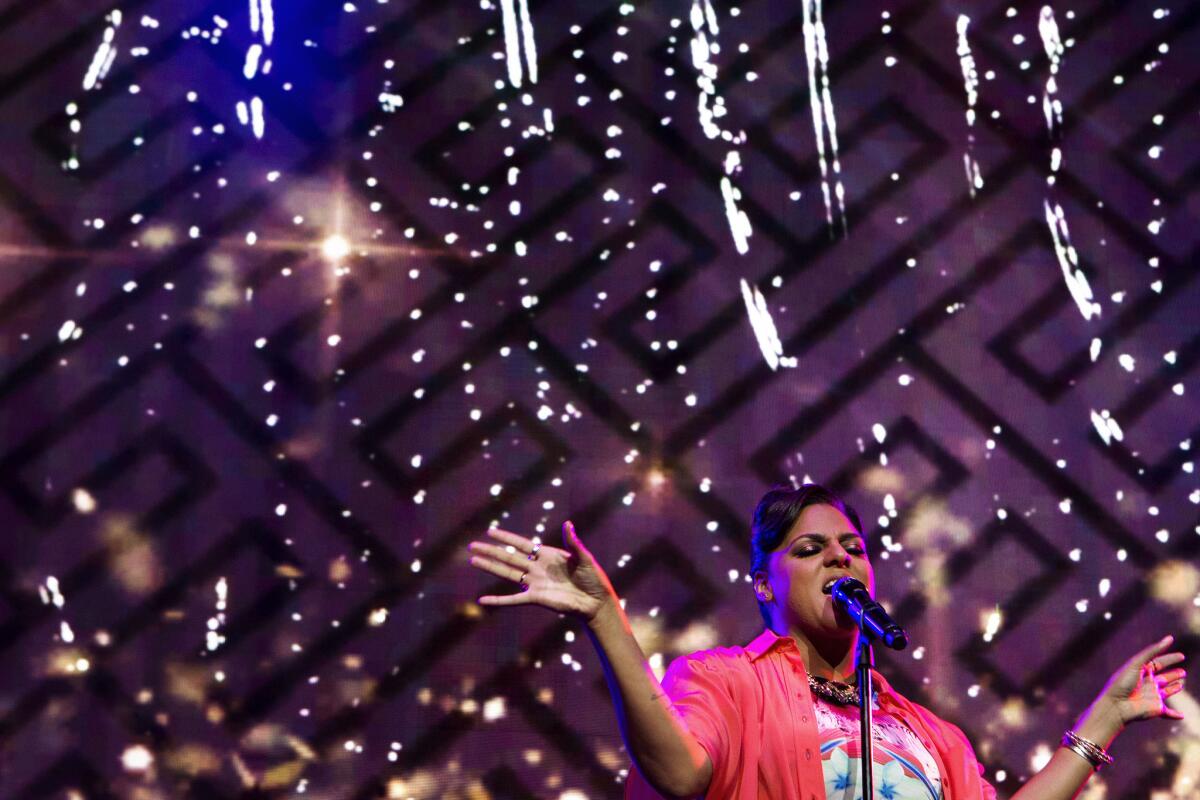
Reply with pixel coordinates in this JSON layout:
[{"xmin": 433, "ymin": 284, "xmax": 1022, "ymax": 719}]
[{"xmin": 755, "ymin": 505, "xmax": 875, "ymax": 640}]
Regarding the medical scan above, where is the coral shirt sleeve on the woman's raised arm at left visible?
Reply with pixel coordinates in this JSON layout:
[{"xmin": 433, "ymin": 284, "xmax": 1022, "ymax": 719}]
[{"xmin": 625, "ymin": 654, "xmax": 742, "ymax": 800}]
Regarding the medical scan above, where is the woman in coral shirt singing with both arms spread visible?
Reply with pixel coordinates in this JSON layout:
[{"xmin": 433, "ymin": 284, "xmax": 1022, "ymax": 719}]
[{"xmin": 469, "ymin": 485, "xmax": 1184, "ymax": 800}]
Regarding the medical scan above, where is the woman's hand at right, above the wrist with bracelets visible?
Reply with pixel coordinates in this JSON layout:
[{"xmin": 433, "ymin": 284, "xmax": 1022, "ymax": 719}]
[{"xmin": 1096, "ymin": 636, "xmax": 1187, "ymax": 727}]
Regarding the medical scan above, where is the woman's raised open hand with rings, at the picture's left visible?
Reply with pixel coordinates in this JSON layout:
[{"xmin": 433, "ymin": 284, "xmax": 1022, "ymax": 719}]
[{"xmin": 467, "ymin": 522, "xmax": 618, "ymax": 621}]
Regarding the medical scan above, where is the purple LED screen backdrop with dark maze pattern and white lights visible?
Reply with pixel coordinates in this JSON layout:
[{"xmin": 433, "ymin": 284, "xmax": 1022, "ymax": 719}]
[{"xmin": 0, "ymin": 0, "xmax": 1200, "ymax": 800}]
